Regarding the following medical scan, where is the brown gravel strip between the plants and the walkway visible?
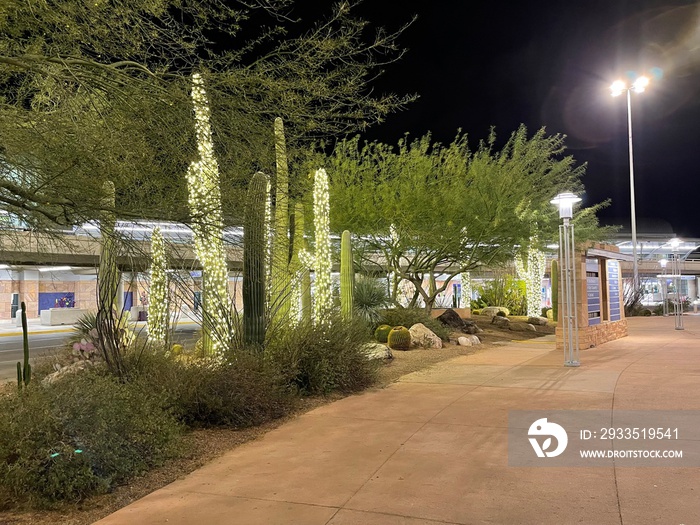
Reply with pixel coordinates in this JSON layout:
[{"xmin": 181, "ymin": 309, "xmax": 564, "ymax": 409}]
[{"xmin": 0, "ymin": 316, "xmax": 554, "ymax": 525}]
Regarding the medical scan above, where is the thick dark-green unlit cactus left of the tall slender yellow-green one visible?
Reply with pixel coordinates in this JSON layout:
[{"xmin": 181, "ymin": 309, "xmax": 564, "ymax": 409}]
[{"xmin": 243, "ymin": 172, "xmax": 268, "ymax": 345}]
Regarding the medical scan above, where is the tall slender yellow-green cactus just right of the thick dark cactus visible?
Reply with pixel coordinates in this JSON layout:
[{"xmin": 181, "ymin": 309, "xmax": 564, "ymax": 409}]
[{"xmin": 270, "ymin": 117, "xmax": 291, "ymax": 322}]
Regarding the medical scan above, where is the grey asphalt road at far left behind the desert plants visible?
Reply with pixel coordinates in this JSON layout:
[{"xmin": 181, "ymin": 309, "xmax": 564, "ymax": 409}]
[{"xmin": 0, "ymin": 325, "xmax": 198, "ymax": 381}]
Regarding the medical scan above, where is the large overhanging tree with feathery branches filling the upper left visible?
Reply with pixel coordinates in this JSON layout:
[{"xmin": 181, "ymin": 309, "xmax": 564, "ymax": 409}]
[{"xmin": 0, "ymin": 0, "xmax": 410, "ymax": 230}]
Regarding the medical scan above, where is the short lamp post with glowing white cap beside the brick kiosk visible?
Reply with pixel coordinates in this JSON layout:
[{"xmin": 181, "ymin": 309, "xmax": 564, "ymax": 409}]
[{"xmin": 550, "ymin": 192, "xmax": 581, "ymax": 366}]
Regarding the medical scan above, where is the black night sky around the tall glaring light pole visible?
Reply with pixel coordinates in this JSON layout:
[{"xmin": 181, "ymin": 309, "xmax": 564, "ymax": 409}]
[{"xmin": 312, "ymin": 0, "xmax": 700, "ymax": 237}]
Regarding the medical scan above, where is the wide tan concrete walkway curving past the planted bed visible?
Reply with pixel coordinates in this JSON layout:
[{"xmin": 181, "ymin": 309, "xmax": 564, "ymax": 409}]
[{"xmin": 98, "ymin": 317, "xmax": 700, "ymax": 525}]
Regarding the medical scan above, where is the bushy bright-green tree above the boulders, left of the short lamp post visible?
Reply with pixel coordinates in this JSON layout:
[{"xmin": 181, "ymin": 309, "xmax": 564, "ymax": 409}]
[{"xmin": 326, "ymin": 126, "xmax": 608, "ymax": 309}]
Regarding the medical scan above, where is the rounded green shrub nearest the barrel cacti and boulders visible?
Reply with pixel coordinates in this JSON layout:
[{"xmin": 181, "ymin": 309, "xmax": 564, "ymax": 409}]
[{"xmin": 266, "ymin": 318, "xmax": 378, "ymax": 394}]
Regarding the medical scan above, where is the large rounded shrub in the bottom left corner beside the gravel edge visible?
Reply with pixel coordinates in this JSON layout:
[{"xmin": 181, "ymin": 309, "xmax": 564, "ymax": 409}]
[{"xmin": 0, "ymin": 371, "xmax": 181, "ymax": 506}]
